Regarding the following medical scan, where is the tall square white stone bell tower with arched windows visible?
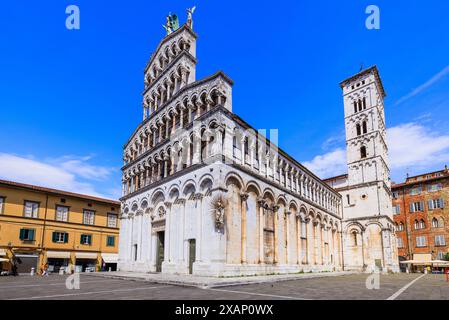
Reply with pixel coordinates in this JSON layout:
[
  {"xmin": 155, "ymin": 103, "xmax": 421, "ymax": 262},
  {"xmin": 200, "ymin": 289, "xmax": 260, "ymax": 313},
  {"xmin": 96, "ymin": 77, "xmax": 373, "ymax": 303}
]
[{"xmin": 340, "ymin": 66, "xmax": 397, "ymax": 271}]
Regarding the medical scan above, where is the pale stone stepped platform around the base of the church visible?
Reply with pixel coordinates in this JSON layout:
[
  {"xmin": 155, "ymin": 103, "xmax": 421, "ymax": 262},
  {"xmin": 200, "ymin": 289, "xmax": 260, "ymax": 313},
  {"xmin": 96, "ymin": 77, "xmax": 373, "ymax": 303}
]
[{"xmin": 88, "ymin": 271, "xmax": 355, "ymax": 288}]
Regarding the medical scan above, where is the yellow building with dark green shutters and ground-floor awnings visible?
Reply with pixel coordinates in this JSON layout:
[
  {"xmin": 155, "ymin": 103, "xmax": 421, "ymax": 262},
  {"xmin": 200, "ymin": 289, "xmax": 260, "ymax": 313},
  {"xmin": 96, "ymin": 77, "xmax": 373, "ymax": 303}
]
[{"xmin": 0, "ymin": 180, "xmax": 120, "ymax": 273}]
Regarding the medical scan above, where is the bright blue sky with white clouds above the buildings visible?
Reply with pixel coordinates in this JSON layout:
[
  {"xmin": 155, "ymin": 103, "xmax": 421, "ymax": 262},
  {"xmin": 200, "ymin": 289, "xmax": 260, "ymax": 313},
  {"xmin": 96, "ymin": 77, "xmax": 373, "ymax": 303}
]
[{"xmin": 0, "ymin": 0, "xmax": 449, "ymax": 198}]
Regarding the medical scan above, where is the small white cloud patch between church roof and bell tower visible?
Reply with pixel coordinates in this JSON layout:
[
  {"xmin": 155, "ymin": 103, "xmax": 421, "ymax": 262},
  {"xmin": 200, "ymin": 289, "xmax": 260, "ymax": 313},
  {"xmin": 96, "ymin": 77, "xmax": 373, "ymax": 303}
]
[{"xmin": 303, "ymin": 148, "xmax": 347, "ymax": 178}]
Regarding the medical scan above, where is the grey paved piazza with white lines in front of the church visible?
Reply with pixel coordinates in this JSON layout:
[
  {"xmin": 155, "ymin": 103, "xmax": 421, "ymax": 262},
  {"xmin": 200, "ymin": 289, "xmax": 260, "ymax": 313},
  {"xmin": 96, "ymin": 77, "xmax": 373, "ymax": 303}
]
[{"xmin": 0, "ymin": 274, "xmax": 449, "ymax": 300}]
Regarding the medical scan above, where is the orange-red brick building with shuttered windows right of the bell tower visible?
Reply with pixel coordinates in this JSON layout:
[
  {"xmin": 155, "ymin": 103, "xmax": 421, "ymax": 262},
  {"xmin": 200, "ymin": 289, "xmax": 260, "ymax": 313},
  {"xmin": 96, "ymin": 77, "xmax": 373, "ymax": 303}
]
[{"xmin": 391, "ymin": 166, "xmax": 449, "ymax": 267}]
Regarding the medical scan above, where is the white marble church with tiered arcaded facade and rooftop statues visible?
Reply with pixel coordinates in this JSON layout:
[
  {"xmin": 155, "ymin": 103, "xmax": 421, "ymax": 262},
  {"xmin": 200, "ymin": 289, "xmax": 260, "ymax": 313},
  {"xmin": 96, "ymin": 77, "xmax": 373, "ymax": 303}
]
[{"xmin": 118, "ymin": 11, "xmax": 394, "ymax": 276}]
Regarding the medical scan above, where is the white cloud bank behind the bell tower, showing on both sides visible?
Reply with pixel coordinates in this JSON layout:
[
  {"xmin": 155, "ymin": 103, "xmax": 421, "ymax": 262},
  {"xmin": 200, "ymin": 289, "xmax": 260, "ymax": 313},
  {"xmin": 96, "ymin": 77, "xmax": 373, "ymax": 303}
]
[{"xmin": 304, "ymin": 123, "xmax": 449, "ymax": 178}]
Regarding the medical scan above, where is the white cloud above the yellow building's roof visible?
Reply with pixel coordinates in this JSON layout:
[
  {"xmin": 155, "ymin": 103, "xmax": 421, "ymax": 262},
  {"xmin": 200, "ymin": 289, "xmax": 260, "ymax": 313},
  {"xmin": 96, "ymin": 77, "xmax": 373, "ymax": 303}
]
[{"xmin": 0, "ymin": 153, "xmax": 116, "ymax": 197}]
